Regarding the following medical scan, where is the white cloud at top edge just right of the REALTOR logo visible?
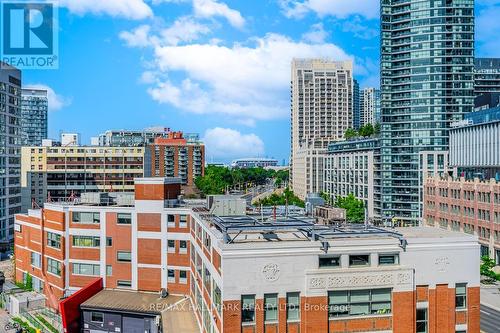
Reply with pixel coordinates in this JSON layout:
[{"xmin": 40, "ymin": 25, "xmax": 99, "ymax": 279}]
[{"xmin": 59, "ymin": 0, "xmax": 153, "ymax": 20}]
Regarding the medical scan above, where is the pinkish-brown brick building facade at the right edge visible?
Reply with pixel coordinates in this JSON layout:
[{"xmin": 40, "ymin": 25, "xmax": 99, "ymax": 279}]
[{"xmin": 424, "ymin": 177, "xmax": 500, "ymax": 265}]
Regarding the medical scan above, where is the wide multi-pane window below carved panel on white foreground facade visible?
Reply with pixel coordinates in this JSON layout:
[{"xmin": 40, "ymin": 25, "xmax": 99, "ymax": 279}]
[{"xmin": 328, "ymin": 289, "xmax": 391, "ymax": 317}]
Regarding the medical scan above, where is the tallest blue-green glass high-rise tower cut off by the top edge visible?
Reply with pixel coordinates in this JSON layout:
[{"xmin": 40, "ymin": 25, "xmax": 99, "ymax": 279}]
[{"xmin": 381, "ymin": 0, "xmax": 474, "ymax": 224}]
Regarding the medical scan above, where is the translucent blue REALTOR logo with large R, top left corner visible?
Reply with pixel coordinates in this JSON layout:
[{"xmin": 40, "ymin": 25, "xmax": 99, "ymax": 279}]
[{"xmin": 0, "ymin": 0, "xmax": 59, "ymax": 69}]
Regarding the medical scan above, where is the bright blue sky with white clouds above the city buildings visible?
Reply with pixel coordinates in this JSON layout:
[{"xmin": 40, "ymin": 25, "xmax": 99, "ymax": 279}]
[{"xmin": 23, "ymin": 0, "xmax": 500, "ymax": 162}]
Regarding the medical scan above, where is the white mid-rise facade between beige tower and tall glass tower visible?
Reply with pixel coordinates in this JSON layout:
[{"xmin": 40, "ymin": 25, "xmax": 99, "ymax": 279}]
[{"xmin": 324, "ymin": 138, "xmax": 380, "ymax": 220}]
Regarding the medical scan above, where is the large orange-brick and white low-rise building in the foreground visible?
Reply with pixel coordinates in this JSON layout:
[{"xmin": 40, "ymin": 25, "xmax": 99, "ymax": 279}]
[{"xmin": 15, "ymin": 178, "xmax": 480, "ymax": 333}]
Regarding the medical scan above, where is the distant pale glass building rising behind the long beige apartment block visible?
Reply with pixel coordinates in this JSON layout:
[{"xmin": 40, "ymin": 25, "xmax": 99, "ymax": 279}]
[{"xmin": 98, "ymin": 127, "xmax": 170, "ymax": 147}]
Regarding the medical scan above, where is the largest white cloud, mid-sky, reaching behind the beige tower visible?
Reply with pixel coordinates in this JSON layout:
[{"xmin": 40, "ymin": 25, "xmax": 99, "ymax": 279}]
[{"xmin": 145, "ymin": 34, "xmax": 350, "ymax": 124}]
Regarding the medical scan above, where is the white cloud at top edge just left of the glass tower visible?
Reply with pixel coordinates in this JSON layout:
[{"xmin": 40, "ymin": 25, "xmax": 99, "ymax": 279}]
[{"xmin": 280, "ymin": 0, "xmax": 380, "ymax": 19}]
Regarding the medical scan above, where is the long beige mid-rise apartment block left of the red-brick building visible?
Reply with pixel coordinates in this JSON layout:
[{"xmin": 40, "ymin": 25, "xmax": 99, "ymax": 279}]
[{"xmin": 21, "ymin": 146, "xmax": 144, "ymax": 211}]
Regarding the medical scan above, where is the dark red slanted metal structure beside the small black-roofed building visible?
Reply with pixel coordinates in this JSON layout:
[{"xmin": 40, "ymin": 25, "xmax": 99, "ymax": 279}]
[{"xmin": 59, "ymin": 278, "xmax": 103, "ymax": 333}]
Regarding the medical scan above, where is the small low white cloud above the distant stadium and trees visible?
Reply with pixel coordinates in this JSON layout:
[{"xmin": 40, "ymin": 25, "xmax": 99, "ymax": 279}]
[{"xmin": 203, "ymin": 127, "xmax": 264, "ymax": 158}]
